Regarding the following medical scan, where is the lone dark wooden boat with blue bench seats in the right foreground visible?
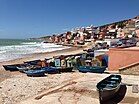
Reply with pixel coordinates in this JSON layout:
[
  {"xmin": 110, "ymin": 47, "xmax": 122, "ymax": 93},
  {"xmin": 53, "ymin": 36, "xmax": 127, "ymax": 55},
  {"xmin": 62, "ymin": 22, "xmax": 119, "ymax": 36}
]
[{"xmin": 96, "ymin": 75, "xmax": 122, "ymax": 101}]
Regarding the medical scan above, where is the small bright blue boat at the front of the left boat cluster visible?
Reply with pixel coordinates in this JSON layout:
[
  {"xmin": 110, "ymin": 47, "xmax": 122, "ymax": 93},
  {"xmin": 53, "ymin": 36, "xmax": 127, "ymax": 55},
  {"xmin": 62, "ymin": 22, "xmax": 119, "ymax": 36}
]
[{"xmin": 24, "ymin": 69, "xmax": 45, "ymax": 77}]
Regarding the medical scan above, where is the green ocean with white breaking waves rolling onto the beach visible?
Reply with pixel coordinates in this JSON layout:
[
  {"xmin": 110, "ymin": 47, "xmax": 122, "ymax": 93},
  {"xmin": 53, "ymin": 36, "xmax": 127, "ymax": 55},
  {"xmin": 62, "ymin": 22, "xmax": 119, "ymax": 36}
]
[{"xmin": 0, "ymin": 39, "xmax": 68, "ymax": 62}]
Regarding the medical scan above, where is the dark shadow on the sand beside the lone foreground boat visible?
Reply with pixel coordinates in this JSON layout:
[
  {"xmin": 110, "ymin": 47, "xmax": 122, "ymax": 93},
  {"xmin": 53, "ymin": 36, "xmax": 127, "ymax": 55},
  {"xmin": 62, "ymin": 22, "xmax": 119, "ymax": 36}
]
[{"xmin": 100, "ymin": 85, "xmax": 127, "ymax": 104}]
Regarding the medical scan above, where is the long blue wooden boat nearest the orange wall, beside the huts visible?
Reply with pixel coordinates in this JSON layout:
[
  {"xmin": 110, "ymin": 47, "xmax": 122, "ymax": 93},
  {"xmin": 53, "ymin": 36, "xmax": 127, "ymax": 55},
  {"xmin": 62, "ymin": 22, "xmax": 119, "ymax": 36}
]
[{"xmin": 75, "ymin": 66, "xmax": 106, "ymax": 73}]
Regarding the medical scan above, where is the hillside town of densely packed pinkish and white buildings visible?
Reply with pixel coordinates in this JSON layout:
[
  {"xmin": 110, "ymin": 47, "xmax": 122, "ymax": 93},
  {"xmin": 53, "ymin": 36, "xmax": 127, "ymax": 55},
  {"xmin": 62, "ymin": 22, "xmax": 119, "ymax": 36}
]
[{"xmin": 50, "ymin": 16, "xmax": 139, "ymax": 45}]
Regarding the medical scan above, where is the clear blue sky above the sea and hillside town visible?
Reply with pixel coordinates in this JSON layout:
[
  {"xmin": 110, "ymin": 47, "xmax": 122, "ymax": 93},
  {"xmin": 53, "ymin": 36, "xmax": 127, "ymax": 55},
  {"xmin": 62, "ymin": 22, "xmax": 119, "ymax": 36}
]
[{"xmin": 0, "ymin": 0, "xmax": 139, "ymax": 38}]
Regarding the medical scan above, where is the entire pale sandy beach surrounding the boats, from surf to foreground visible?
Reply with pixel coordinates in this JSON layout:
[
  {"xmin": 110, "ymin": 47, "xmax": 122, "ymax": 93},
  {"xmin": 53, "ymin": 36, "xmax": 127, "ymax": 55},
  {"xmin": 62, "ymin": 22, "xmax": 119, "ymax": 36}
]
[{"xmin": 0, "ymin": 47, "xmax": 139, "ymax": 104}]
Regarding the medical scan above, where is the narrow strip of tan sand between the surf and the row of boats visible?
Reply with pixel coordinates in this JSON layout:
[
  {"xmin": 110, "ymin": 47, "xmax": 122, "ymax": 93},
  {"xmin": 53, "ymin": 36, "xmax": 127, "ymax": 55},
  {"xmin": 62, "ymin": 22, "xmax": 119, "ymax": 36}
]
[{"xmin": 0, "ymin": 47, "xmax": 83, "ymax": 66}]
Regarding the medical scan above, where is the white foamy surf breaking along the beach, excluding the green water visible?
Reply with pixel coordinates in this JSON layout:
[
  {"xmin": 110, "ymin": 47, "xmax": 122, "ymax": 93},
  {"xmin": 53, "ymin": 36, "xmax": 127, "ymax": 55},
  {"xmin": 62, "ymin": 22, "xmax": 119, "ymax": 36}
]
[{"xmin": 0, "ymin": 42, "xmax": 68, "ymax": 62}]
